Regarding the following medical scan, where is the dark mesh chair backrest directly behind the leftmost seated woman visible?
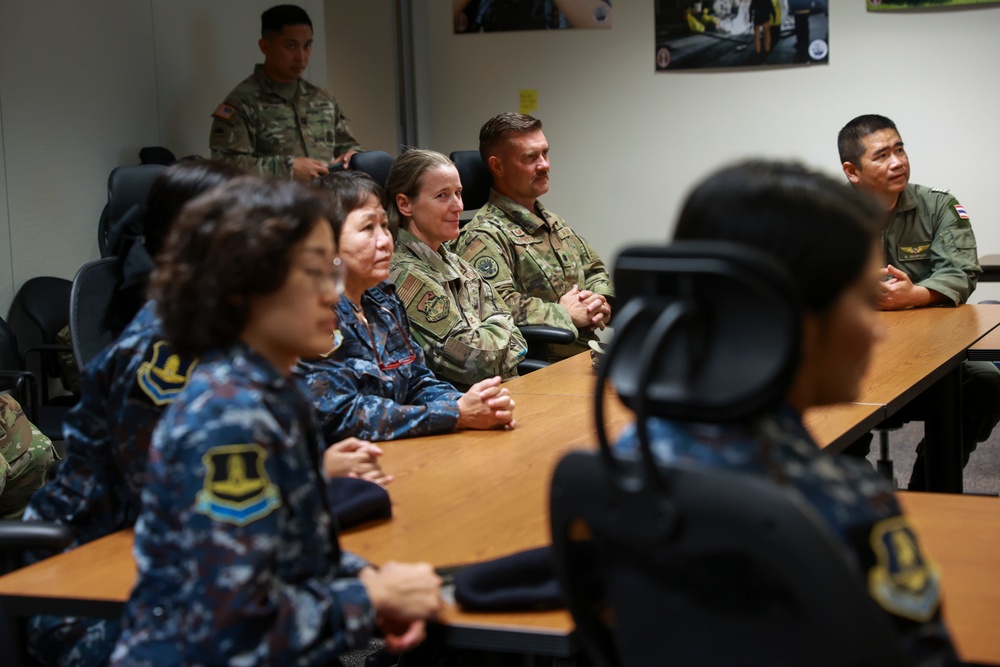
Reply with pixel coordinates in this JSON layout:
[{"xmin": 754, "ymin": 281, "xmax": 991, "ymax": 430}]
[{"xmin": 70, "ymin": 257, "xmax": 118, "ymax": 368}]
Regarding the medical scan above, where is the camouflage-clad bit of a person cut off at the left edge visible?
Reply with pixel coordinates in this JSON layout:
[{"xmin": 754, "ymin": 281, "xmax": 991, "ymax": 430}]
[{"xmin": 0, "ymin": 394, "xmax": 55, "ymax": 519}]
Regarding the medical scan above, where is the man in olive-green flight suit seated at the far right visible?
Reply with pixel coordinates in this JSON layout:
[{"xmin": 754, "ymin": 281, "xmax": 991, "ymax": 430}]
[{"xmin": 837, "ymin": 114, "xmax": 1000, "ymax": 491}]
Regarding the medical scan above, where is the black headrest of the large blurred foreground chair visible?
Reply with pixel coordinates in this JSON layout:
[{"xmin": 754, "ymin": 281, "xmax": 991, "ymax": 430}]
[{"xmin": 602, "ymin": 241, "xmax": 802, "ymax": 422}]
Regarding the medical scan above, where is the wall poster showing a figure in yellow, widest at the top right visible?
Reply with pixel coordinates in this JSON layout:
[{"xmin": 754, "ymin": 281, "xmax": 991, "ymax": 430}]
[{"xmin": 654, "ymin": 0, "xmax": 830, "ymax": 72}]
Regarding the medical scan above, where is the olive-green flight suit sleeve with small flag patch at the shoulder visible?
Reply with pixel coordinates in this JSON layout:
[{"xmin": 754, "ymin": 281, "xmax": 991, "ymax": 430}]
[{"xmin": 917, "ymin": 196, "xmax": 982, "ymax": 305}]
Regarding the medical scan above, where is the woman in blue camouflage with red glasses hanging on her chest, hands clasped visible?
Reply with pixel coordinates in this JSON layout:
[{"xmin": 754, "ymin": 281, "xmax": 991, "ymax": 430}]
[{"xmin": 296, "ymin": 171, "xmax": 514, "ymax": 448}]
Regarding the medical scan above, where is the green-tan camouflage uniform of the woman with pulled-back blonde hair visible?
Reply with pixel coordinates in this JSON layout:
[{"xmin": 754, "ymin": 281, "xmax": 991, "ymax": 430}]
[{"xmin": 390, "ymin": 229, "xmax": 528, "ymax": 388}]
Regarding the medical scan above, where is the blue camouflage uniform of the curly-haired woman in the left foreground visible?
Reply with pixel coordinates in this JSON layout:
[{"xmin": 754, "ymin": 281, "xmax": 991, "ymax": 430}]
[{"xmin": 111, "ymin": 342, "xmax": 374, "ymax": 667}]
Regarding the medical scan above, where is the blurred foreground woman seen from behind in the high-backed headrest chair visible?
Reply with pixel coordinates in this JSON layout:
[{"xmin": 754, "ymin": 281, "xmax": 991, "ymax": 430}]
[{"xmin": 617, "ymin": 162, "xmax": 956, "ymax": 665}]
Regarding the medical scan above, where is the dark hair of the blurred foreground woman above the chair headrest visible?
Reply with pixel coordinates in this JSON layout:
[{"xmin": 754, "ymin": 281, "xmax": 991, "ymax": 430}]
[{"xmin": 674, "ymin": 160, "xmax": 882, "ymax": 313}]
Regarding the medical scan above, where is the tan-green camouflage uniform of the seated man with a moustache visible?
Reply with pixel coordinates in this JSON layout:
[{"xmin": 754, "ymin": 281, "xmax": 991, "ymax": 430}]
[{"xmin": 455, "ymin": 189, "xmax": 614, "ymax": 359}]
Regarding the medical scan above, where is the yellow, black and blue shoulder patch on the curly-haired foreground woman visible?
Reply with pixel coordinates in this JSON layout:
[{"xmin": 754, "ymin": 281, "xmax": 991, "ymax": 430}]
[{"xmin": 195, "ymin": 444, "xmax": 281, "ymax": 526}]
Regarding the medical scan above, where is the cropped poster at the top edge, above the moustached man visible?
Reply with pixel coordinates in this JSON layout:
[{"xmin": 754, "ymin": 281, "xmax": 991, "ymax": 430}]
[{"xmin": 452, "ymin": 0, "xmax": 612, "ymax": 34}]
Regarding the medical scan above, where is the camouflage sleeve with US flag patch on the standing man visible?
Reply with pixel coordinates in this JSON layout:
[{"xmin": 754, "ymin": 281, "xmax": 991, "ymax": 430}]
[{"xmin": 208, "ymin": 95, "xmax": 295, "ymax": 178}]
